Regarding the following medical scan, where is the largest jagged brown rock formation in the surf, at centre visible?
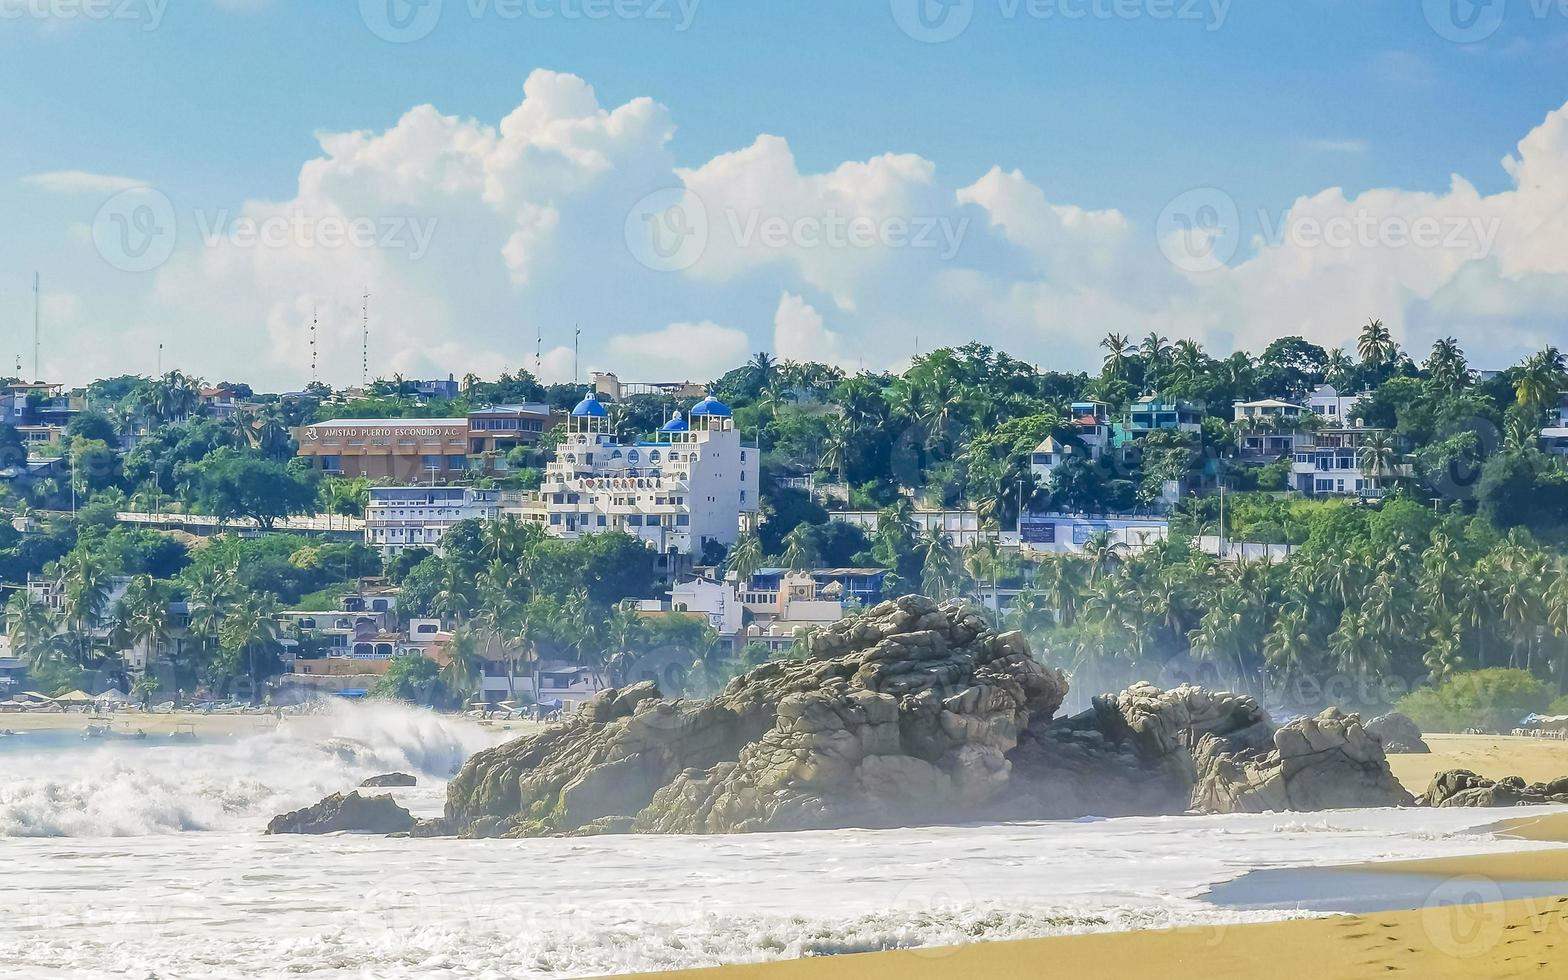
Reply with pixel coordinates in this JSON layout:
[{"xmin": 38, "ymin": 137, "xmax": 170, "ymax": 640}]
[{"xmin": 435, "ymin": 596, "xmax": 1411, "ymax": 837}]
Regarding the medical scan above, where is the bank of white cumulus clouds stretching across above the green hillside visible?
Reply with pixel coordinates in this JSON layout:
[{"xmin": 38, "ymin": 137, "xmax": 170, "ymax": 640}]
[{"xmin": 33, "ymin": 71, "xmax": 1568, "ymax": 387}]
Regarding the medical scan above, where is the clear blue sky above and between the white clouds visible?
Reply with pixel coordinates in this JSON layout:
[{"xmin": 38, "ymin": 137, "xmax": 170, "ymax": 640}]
[{"xmin": 0, "ymin": 0, "xmax": 1568, "ymax": 384}]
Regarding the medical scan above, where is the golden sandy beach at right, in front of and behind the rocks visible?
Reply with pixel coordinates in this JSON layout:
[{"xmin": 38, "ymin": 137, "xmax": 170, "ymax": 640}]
[{"xmin": 614, "ymin": 735, "xmax": 1568, "ymax": 980}]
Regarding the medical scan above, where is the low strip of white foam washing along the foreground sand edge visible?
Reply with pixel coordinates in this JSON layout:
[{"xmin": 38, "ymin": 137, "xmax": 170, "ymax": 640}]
[{"xmin": 0, "ymin": 905, "xmax": 1303, "ymax": 980}]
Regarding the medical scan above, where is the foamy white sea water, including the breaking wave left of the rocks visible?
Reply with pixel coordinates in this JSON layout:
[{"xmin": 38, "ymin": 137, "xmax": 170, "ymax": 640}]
[{"xmin": 0, "ymin": 706, "xmax": 1561, "ymax": 980}]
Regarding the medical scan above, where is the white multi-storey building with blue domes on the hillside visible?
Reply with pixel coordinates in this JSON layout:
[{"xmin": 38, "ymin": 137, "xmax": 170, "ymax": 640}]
[{"xmin": 516, "ymin": 395, "xmax": 760, "ymax": 572}]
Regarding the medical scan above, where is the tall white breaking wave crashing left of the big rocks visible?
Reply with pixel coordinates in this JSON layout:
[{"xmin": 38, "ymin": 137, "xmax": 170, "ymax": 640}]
[{"xmin": 0, "ymin": 704, "xmax": 495, "ymax": 837}]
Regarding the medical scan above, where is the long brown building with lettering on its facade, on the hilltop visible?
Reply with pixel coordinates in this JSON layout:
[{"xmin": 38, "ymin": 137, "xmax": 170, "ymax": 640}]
[{"xmin": 295, "ymin": 405, "xmax": 554, "ymax": 485}]
